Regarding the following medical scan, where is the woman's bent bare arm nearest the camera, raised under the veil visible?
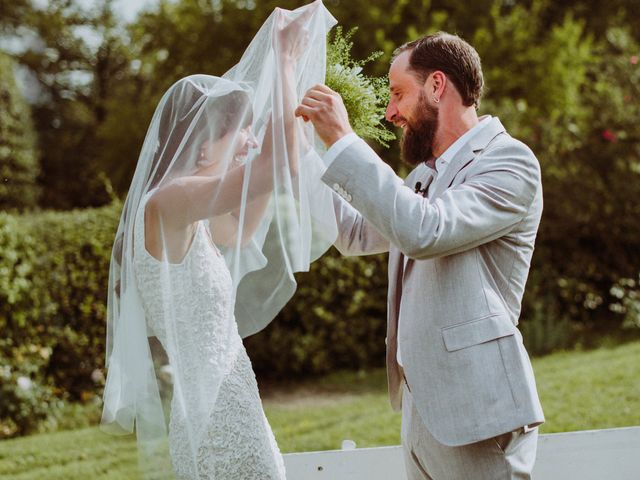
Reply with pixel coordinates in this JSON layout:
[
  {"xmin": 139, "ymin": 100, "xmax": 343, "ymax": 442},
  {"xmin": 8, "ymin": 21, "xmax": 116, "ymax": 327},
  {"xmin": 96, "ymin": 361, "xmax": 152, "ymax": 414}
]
[{"xmin": 148, "ymin": 9, "xmax": 308, "ymax": 232}]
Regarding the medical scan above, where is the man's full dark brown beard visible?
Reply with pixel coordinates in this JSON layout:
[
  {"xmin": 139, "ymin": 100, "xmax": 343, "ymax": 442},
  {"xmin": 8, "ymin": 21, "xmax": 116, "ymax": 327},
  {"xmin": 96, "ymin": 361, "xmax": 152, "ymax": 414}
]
[{"xmin": 400, "ymin": 94, "xmax": 438, "ymax": 167}]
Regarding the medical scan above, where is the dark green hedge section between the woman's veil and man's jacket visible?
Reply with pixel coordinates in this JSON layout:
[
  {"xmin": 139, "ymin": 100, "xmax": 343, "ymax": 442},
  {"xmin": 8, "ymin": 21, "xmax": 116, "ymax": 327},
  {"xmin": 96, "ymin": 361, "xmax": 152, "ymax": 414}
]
[{"xmin": 245, "ymin": 249, "xmax": 387, "ymax": 378}]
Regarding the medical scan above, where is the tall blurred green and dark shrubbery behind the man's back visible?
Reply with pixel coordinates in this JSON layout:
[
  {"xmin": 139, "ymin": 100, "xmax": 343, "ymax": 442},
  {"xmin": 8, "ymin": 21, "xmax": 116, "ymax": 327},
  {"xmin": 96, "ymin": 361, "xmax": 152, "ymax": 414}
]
[{"xmin": 471, "ymin": 6, "xmax": 640, "ymax": 353}]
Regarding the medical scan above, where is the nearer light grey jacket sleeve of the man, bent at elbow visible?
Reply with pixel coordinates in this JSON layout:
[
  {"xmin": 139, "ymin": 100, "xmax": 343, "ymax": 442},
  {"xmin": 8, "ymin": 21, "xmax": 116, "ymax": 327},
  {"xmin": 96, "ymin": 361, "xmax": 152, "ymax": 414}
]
[{"xmin": 322, "ymin": 140, "xmax": 540, "ymax": 260}]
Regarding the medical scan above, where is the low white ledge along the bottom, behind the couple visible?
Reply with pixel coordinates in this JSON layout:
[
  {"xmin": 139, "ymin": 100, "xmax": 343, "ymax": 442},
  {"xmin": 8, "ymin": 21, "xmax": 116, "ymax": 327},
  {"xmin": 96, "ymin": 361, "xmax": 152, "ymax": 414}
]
[{"xmin": 284, "ymin": 427, "xmax": 640, "ymax": 480}]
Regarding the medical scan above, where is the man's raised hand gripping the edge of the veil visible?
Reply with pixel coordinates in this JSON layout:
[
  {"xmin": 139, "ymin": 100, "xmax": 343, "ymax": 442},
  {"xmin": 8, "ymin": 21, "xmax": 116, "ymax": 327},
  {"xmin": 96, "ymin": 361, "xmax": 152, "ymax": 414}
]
[{"xmin": 295, "ymin": 85, "xmax": 353, "ymax": 148}]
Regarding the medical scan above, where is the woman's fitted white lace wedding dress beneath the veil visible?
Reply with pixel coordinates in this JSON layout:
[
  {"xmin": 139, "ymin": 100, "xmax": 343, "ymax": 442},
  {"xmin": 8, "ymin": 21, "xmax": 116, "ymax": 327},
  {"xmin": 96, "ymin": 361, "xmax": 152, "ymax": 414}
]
[{"xmin": 134, "ymin": 194, "xmax": 285, "ymax": 480}]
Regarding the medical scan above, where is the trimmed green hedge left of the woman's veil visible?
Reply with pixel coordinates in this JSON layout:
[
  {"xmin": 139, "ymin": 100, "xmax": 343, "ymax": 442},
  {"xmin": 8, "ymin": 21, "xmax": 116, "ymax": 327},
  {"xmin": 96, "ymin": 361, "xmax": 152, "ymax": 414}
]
[{"xmin": 0, "ymin": 203, "xmax": 121, "ymax": 436}]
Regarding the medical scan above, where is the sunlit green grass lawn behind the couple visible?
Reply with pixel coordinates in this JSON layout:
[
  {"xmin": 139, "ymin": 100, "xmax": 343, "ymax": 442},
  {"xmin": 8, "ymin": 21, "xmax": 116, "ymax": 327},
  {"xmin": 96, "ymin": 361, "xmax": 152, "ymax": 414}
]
[{"xmin": 0, "ymin": 342, "xmax": 640, "ymax": 480}]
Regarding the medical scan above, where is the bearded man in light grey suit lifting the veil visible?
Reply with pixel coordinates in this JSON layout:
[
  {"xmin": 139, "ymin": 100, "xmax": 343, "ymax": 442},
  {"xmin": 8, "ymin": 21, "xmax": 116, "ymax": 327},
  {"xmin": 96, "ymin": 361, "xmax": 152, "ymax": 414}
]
[{"xmin": 296, "ymin": 32, "xmax": 544, "ymax": 480}]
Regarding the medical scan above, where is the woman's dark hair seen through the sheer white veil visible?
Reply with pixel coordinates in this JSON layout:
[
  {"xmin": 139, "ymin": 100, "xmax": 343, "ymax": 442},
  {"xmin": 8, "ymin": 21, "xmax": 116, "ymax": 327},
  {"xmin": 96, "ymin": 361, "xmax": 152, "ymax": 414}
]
[{"xmin": 149, "ymin": 77, "xmax": 252, "ymax": 189}]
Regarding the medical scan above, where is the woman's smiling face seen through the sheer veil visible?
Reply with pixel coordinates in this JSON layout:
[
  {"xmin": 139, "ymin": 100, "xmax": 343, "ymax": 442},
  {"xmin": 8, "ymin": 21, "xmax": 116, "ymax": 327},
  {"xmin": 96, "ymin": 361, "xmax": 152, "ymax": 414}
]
[{"xmin": 196, "ymin": 126, "xmax": 258, "ymax": 176}]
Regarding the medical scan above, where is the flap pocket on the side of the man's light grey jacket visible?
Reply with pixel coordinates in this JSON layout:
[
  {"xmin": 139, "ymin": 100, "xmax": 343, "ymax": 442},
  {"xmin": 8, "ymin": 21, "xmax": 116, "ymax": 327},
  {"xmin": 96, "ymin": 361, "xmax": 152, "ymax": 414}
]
[{"xmin": 442, "ymin": 313, "xmax": 516, "ymax": 352}]
